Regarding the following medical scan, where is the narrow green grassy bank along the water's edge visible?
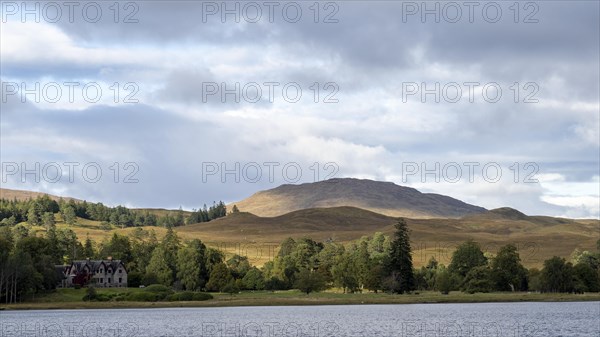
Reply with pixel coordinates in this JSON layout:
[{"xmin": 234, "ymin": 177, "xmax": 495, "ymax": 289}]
[{"xmin": 0, "ymin": 288, "xmax": 600, "ymax": 310}]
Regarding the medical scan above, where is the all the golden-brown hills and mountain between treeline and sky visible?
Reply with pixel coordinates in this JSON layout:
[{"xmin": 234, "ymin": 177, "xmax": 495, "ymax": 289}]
[{"xmin": 2, "ymin": 184, "xmax": 600, "ymax": 267}]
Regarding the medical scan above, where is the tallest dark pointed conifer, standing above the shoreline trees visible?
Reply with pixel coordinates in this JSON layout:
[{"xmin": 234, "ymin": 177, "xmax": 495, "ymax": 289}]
[{"xmin": 387, "ymin": 218, "xmax": 415, "ymax": 294}]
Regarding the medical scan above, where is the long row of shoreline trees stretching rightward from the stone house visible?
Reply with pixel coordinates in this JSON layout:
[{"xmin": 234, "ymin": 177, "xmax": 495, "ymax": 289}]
[{"xmin": 99, "ymin": 220, "xmax": 600, "ymax": 293}]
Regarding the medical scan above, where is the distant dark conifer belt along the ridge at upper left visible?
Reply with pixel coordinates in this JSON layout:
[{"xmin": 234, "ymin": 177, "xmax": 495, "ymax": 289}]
[{"xmin": 0, "ymin": 195, "xmax": 227, "ymax": 228}]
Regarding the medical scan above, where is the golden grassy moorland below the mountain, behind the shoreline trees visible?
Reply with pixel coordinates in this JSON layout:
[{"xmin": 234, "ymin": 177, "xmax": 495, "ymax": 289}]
[{"xmin": 22, "ymin": 207, "xmax": 600, "ymax": 268}]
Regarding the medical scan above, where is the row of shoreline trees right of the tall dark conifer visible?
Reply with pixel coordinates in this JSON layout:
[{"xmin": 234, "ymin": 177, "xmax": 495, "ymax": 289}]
[{"xmin": 415, "ymin": 240, "xmax": 600, "ymax": 294}]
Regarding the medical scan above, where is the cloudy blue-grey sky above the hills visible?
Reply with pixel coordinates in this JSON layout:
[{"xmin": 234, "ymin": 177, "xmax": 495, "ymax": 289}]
[{"xmin": 0, "ymin": 1, "xmax": 600, "ymax": 218}]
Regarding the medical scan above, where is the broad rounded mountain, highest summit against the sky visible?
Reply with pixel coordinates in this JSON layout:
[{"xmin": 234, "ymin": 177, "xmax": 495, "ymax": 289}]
[{"xmin": 229, "ymin": 178, "xmax": 486, "ymax": 219}]
